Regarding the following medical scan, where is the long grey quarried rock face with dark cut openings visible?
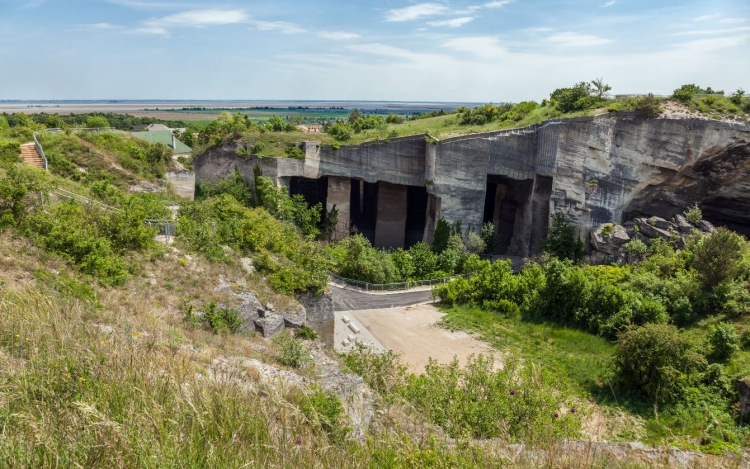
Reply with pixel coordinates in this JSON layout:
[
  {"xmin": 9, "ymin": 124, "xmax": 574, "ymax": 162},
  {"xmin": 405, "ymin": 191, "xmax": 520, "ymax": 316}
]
[{"xmin": 194, "ymin": 114, "xmax": 750, "ymax": 255}]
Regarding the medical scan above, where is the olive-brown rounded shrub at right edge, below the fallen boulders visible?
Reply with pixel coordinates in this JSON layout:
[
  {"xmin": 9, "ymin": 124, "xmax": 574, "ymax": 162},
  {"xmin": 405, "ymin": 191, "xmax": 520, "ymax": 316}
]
[{"xmin": 693, "ymin": 227, "xmax": 746, "ymax": 289}]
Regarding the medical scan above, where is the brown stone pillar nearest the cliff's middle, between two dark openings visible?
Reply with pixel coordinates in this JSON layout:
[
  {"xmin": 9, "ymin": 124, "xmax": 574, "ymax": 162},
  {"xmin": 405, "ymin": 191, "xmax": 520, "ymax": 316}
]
[{"xmin": 375, "ymin": 181, "xmax": 407, "ymax": 249}]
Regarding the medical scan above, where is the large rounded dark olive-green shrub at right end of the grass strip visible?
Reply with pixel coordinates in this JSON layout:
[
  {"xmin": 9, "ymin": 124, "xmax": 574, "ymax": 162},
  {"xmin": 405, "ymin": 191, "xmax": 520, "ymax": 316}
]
[{"xmin": 615, "ymin": 324, "xmax": 706, "ymax": 402}]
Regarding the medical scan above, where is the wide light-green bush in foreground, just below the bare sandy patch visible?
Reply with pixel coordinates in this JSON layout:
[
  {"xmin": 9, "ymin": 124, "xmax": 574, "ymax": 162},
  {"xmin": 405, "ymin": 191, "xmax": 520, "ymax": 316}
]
[{"xmin": 403, "ymin": 355, "xmax": 581, "ymax": 444}]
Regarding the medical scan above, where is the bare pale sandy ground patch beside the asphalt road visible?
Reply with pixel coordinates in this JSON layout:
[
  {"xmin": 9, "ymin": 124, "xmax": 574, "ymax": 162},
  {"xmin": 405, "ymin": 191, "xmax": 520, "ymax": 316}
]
[{"xmin": 336, "ymin": 305, "xmax": 497, "ymax": 372}]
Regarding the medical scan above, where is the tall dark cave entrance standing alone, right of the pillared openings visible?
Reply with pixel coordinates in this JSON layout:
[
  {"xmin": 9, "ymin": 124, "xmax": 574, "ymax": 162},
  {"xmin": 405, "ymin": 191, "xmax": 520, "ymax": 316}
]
[{"xmin": 483, "ymin": 174, "xmax": 534, "ymax": 255}]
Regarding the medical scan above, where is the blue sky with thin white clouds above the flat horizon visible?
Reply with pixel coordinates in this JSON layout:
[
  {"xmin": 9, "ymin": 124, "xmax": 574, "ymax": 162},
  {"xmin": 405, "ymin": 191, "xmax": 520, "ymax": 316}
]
[{"xmin": 0, "ymin": 0, "xmax": 750, "ymax": 102}]
